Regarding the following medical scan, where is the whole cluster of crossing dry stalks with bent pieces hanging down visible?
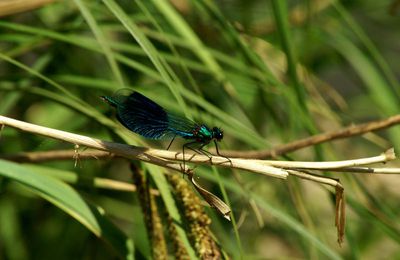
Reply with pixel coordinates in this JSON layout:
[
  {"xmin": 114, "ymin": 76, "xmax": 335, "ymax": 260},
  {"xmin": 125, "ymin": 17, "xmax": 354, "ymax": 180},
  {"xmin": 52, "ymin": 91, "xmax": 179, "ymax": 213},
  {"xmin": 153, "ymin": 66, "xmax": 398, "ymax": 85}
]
[{"xmin": 0, "ymin": 115, "xmax": 400, "ymax": 244}]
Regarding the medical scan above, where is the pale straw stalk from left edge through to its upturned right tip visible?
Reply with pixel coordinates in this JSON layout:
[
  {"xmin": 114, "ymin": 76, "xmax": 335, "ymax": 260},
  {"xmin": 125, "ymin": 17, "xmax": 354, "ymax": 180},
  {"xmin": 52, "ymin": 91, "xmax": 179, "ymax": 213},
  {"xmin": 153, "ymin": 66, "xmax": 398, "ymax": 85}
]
[{"xmin": 0, "ymin": 116, "xmax": 395, "ymax": 178}]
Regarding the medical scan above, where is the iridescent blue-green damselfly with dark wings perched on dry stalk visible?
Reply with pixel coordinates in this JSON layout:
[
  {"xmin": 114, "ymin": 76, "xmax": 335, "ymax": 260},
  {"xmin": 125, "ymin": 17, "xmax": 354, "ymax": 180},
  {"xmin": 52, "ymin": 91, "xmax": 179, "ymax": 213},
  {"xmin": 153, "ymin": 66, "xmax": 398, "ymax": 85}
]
[{"xmin": 101, "ymin": 91, "xmax": 230, "ymax": 169}]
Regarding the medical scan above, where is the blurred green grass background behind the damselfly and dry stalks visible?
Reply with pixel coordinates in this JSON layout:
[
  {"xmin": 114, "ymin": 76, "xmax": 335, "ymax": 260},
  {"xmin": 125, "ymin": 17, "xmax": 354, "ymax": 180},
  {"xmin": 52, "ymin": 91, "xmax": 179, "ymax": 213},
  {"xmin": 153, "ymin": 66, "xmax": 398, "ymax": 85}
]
[{"xmin": 0, "ymin": 0, "xmax": 400, "ymax": 259}]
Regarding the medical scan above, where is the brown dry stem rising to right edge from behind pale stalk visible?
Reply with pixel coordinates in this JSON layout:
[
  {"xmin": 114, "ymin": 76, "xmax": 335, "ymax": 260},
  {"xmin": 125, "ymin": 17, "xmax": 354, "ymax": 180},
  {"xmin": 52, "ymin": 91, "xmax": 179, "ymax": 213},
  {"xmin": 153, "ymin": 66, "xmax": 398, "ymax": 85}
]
[{"xmin": 221, "ymin": 115, "xmax": 400, "ymax": 159}]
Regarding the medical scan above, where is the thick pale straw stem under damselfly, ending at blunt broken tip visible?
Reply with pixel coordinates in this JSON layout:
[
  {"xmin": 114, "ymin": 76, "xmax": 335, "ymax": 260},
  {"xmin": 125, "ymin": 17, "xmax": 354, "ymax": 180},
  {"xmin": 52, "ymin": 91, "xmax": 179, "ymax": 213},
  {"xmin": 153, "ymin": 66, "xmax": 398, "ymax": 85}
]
[{"xmin": 0, "ymin": 116, "xmax": 288, "ymax": 179}]
